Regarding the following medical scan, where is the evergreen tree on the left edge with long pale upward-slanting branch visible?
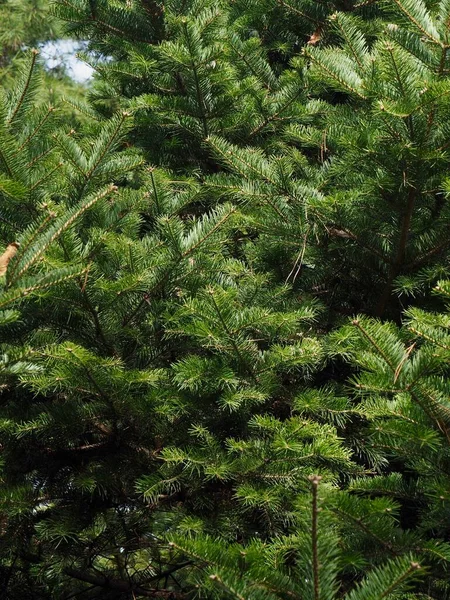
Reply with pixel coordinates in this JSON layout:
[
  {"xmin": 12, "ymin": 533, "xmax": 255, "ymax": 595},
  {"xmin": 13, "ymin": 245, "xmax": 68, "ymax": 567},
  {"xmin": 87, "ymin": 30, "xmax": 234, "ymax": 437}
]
[{"xmin": 0, "ymin": 51, "xmax": 149, "ymax": 597}]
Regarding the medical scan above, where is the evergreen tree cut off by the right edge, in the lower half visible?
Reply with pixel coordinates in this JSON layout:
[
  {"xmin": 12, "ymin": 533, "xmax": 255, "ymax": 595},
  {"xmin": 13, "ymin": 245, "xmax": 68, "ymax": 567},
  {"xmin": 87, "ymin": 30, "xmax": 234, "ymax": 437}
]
[{"xmin": 335, "ymin": 281, "xmax": 450, "ymax": 598}]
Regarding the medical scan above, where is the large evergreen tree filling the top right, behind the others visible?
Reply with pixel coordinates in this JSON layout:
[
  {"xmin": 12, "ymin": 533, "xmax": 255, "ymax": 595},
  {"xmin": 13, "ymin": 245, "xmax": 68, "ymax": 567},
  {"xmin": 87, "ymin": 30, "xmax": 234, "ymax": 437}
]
[{"xmin": 52, "ymin": 0, "xmax": 448, "ymax": 320}]
